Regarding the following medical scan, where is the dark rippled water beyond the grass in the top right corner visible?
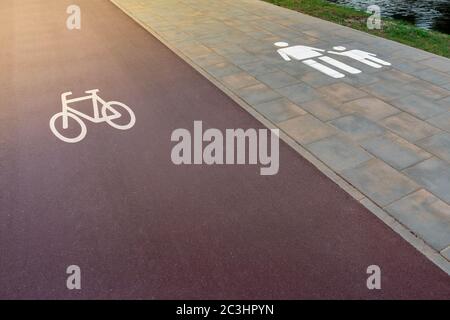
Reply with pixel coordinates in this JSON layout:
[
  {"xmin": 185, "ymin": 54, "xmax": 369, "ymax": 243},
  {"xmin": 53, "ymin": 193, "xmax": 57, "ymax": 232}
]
[{"xmin": 328, "ymin": 0, "xmax": 450, "ymax": 34}]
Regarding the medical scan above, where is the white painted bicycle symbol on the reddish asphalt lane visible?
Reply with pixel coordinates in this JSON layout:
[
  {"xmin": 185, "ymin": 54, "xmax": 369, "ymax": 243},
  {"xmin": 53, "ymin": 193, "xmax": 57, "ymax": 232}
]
[{"xmin": 50, "ymin": 89, "xmax": 136, "ymax": 143}]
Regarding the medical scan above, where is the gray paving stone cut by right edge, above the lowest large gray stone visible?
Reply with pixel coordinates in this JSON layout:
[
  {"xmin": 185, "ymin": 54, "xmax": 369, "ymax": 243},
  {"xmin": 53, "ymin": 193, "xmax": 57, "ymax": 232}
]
[{"xmin": 403, "ymin": 157, "xmax": 450, "ymax": 203}]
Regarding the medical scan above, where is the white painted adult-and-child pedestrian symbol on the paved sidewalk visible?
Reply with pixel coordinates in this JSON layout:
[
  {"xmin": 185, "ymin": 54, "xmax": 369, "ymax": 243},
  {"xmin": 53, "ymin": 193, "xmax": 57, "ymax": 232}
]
[{"xmin": 275, "ymin": 42, "xmax": 391, "ymax": 79}]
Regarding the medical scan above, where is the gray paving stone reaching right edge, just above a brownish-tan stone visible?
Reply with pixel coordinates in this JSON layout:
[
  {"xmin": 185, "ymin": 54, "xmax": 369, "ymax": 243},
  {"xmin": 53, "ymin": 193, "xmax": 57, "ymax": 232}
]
[{"xmin": 391, "ymin": 95, "xmax": 448, "ymax": 120}]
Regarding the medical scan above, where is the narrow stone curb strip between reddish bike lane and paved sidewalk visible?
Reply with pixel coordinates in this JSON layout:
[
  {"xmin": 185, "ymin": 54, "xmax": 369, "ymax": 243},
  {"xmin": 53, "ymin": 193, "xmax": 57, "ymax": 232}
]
[{"xmin": 110, "ymin": 0, "xmax": 450, "ymax": 275}]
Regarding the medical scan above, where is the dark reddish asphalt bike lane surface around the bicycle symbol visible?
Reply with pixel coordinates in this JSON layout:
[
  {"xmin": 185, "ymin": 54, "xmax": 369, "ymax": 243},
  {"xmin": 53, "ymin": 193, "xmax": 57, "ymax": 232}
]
[{"xmin": 0, "ymin": 0, "xmax": 450, "ymax": 299}]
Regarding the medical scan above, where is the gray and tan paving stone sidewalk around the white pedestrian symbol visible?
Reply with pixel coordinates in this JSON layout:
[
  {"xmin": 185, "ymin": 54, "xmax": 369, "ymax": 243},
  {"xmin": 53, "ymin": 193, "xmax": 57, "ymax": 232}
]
[{"xmin": 113, "ymin": 0, "xmax": 450, "ymax": 260}]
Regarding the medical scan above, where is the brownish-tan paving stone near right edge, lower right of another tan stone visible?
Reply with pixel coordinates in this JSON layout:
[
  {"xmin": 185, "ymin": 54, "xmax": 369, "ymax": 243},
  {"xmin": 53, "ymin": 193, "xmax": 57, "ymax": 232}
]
[{"xmin": 380, "ymin": 112, "xmax": 440, "ymax": 142}]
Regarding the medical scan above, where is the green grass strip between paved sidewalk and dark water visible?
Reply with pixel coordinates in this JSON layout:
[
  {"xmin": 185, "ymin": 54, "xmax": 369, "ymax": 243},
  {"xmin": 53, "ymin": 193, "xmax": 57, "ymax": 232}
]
[{"xmin": 263, "ymin": 0, "xmax": 450, "ymax": 58}]
